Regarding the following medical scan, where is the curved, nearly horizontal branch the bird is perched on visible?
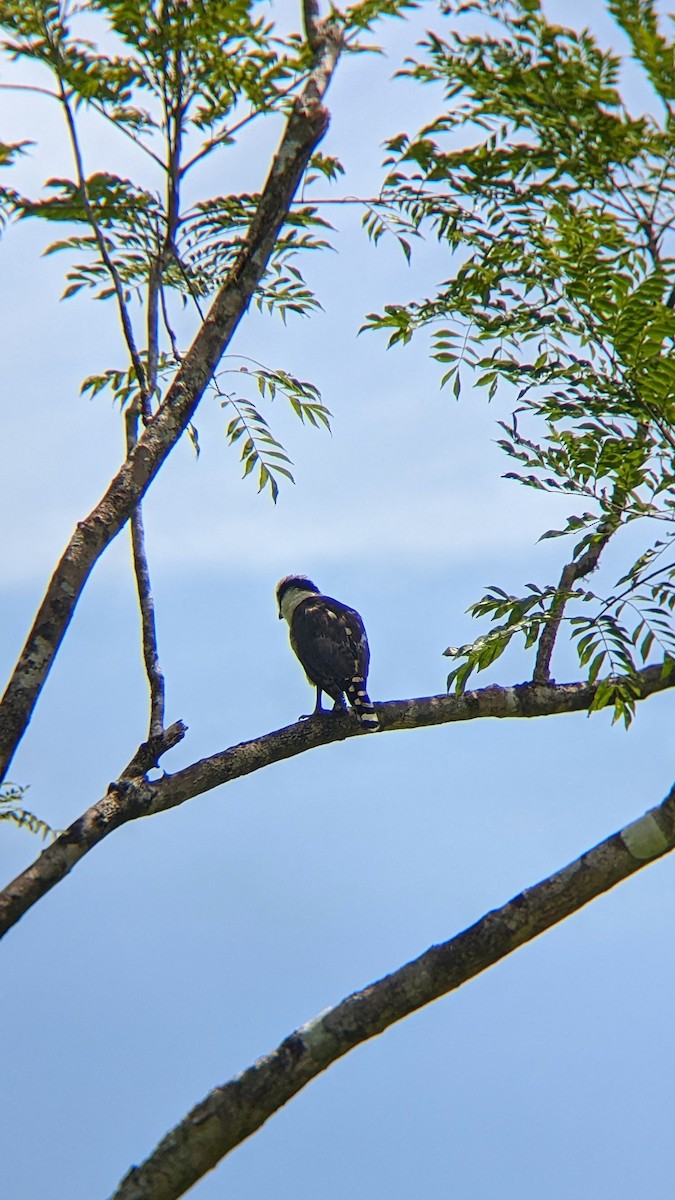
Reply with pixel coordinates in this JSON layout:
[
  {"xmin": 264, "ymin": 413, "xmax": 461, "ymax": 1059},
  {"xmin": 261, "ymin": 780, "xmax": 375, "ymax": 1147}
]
[{"xmin": 0, "ymin": 666, "xmax": 675, "ymax": 937}]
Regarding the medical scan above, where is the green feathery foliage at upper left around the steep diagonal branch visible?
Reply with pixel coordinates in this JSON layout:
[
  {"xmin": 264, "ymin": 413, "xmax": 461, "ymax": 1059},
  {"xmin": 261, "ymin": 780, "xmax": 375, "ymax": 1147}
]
[{"xmin": 0, "ymin": 0, "xmax": 345, "ymax": 498}]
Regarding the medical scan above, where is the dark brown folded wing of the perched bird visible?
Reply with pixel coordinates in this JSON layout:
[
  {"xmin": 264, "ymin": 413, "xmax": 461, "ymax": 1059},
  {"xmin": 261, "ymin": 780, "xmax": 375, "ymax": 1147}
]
[{"xmin": 291, "ymin": 596, "xmax": 370, "ymax": 686}]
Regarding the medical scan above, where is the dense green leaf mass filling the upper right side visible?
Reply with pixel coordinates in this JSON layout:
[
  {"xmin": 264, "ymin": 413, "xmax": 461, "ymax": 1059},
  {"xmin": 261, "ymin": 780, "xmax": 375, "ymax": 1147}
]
[{"xmin": 366, "ymin": 0, "xmax": 675, "ymax": 715}]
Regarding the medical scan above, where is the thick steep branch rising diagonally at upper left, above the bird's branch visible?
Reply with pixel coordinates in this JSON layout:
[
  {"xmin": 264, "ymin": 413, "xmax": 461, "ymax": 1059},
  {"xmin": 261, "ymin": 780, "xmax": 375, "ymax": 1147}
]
[{"xmin": 0, "ymin": 30, "xmax": 341, "ymax": 780}]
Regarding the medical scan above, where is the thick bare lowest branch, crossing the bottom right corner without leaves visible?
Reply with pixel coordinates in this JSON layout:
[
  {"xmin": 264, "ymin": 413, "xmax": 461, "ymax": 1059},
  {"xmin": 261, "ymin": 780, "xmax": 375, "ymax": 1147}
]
[{"xmin": 106, "ymin": 786, "xmax": 675, "ymax": 1200}]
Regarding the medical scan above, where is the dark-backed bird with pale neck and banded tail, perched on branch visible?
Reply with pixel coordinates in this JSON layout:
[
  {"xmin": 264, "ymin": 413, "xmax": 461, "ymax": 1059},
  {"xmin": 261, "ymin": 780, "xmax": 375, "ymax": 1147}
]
[{"xmin": 276, "ymin": 575, "xmax": 380, "ymax": 731}]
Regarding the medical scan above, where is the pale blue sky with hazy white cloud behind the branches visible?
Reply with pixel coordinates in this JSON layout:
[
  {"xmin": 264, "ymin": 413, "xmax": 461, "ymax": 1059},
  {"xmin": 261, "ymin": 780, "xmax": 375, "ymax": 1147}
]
[{"xmin": 0, "ymin": 0, "xmax": 675, "ymax": 1200}]
